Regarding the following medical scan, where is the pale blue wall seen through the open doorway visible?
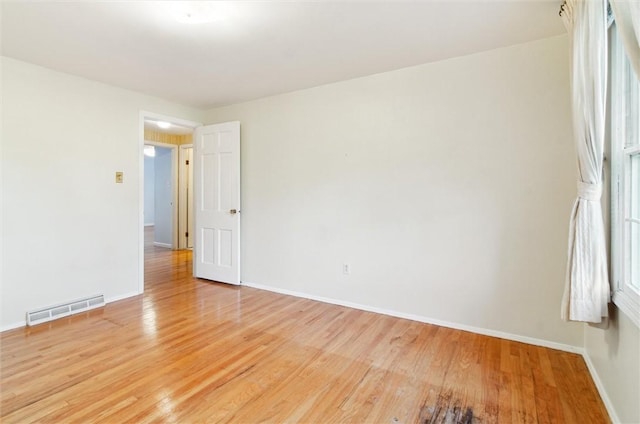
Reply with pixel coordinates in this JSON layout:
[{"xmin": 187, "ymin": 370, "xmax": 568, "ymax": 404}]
[{"xmin": 154, "ymin": 146, "xmax": 173, "ymax": 247}]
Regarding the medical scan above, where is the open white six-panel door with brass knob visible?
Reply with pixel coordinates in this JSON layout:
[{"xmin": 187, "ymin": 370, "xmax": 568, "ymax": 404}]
[{"xmin": 193, "ymin": 122, "xmax": 240, "ymax": 284}]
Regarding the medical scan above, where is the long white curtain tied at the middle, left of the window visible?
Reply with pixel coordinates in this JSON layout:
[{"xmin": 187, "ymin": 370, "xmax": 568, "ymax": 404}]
[{"xmin": 561, "ymin": 0, "xmax": 610, "ymax": 323}]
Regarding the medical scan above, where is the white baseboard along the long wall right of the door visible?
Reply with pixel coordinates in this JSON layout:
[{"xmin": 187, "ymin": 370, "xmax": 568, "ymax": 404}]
[{"xmin": 241, "ymin": 281, "xmax": 584, "ymax": 355}]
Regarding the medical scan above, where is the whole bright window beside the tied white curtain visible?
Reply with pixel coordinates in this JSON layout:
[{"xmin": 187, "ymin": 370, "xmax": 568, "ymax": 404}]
[{"xmin": 609, "ymin": 22, "xmax": 640, "ymax": 327}]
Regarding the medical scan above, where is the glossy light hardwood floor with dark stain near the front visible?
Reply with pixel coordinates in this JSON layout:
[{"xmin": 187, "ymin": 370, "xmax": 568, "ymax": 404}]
[{"xmin": 0, "ymin": 245, "xmax": 609, "ymax": 424}]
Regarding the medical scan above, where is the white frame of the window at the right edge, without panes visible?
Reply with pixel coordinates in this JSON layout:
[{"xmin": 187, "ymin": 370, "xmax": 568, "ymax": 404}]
[{"xmin": 608, "ymin": 18, "xmax": 640, "ymax": 327}]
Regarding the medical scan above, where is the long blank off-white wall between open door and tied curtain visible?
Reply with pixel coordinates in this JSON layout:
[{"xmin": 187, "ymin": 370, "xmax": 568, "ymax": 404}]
[{"xmin": 207, "ymin": 36, "xmax": 583, "ymax": 346}]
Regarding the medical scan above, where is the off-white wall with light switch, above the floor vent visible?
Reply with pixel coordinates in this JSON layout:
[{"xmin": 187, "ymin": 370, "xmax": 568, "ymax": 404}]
[{"xmin": 0, "ymin": 57, "xmax": 202, "ymax": 329}]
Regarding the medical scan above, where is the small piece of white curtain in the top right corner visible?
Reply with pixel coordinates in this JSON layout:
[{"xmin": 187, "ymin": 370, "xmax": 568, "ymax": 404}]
[{"xmin": 610, "ymin": 0, "xmax": 640, "ymax": 78}]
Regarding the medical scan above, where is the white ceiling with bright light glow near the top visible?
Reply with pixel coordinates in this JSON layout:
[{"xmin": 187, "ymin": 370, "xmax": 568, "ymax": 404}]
[{"xmin": 0, "ymin": 0, "xmax": 564, "ymax": 109}]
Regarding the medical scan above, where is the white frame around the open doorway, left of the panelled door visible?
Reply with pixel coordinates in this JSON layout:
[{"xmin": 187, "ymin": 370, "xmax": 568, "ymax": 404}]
[{"xmin": 137, "ymin": 110, "xmax": 202, "ymax": 294}]
